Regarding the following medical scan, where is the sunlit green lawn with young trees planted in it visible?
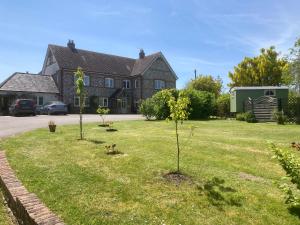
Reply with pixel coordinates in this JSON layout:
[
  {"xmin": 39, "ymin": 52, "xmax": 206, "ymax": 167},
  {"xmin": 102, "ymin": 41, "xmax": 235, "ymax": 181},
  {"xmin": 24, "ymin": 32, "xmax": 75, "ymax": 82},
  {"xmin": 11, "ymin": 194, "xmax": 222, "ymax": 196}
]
[{"xmin": 0, "ymin": 120, "xmax": 300, "ymax": 225}]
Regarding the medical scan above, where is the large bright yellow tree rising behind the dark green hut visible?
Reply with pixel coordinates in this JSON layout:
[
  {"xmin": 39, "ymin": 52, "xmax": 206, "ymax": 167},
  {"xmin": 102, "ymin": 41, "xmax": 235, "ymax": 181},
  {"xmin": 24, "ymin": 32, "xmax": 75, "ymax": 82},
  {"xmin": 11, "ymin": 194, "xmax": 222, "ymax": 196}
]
[{"xmin": 228, "ymin": 46, "xmax": 290, "ymax": 87}]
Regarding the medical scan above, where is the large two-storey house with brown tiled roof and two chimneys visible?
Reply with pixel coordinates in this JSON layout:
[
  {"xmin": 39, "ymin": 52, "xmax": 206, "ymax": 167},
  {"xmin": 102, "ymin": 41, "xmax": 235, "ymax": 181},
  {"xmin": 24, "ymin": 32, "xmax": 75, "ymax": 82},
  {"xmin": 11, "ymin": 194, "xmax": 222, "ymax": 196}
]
[{"xmin": 0, "ymin": 40, "xmax": 177, "ymax": 113}]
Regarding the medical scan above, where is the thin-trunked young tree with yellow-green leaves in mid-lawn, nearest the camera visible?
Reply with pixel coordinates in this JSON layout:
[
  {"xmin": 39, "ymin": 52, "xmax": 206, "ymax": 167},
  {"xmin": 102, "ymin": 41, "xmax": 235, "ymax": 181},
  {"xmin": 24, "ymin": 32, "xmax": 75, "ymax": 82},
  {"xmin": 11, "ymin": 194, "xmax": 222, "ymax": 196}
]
[{"xmin": 168, "ymin": 92, "xmax": 190, "ymax": 173}]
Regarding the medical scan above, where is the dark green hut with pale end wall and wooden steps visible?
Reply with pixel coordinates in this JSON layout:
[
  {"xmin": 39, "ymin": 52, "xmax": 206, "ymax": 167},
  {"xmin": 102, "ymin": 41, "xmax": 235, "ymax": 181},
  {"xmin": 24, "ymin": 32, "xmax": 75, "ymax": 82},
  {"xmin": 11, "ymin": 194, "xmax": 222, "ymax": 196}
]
[{"xmin": 230, "ymin": 86, "xmax": 289, "ymax": 121}]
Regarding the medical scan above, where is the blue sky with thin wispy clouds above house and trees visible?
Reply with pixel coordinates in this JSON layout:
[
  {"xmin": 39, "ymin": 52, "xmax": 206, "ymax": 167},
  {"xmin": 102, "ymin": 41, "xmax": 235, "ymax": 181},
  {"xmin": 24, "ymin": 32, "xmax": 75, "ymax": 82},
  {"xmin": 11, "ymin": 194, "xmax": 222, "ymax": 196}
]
[{"xmin": 0, "ymin": 0, "xmax": 300, "ymax": 88}]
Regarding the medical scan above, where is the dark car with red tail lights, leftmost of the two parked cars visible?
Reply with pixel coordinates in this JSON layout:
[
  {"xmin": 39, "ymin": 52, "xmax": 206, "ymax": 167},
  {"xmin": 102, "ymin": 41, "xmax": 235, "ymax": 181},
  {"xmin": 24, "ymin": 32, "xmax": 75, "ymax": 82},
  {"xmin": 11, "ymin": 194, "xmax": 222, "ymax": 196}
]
[{"xmin": 9, "ymin": 99, "xmax": 36, "ymax": 116}]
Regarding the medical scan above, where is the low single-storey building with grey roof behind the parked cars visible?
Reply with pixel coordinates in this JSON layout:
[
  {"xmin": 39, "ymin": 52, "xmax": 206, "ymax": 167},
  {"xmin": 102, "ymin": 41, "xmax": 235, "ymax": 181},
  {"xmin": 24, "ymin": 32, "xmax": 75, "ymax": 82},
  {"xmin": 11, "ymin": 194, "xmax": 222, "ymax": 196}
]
[{"xmin": 0, "ymin": 72, "xmax": 59, "ymax": 115}]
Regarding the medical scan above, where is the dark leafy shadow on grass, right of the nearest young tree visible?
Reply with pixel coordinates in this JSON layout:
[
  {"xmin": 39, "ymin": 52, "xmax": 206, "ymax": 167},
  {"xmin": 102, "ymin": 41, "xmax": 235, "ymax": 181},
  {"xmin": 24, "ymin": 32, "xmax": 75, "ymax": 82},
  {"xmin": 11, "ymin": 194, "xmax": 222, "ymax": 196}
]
[{"xmin": 197, "ymin": 177, "xmax": 242, "ymax": 210}]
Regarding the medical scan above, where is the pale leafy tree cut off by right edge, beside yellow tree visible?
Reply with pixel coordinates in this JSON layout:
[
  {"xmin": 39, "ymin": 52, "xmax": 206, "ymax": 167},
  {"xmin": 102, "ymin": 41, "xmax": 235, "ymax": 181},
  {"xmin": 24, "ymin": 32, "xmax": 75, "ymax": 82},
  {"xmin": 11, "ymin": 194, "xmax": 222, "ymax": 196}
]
[{"xmin": 289, "ymin": 38, "xmax": 300, "ymax": 93}]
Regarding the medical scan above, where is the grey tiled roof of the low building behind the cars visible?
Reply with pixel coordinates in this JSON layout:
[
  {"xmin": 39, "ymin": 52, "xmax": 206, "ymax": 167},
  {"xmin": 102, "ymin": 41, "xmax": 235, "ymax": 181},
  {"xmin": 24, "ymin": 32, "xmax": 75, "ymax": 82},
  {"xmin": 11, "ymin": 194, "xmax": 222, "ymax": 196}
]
[{"xmin": 0, "ymin": 73, "xmax": 59, "ymax": 93}]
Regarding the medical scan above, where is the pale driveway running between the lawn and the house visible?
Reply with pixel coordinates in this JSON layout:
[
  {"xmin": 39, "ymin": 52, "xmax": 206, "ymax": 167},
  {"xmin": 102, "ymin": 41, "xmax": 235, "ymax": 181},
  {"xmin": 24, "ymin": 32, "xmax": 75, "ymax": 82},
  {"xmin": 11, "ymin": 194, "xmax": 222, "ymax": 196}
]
[{"xmin": 0, "ymin": 114, "xmax": 143, "ymax": 139}]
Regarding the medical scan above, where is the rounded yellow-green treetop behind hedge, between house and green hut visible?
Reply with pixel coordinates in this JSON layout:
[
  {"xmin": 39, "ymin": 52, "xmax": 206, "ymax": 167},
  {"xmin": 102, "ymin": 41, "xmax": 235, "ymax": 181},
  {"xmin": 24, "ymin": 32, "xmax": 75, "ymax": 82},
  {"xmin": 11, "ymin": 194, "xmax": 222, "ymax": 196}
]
[{"xmin": 187, "ymin": 75, "xmax": 222, "ymax": 97}]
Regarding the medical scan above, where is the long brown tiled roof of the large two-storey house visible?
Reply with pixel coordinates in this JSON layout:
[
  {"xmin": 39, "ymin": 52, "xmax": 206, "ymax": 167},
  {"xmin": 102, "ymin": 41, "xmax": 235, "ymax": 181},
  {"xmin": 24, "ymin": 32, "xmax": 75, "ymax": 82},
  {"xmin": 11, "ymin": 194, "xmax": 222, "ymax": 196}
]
[{"xmin": 49, "ymin": 45, "xmax": 161, "ymax": 76}]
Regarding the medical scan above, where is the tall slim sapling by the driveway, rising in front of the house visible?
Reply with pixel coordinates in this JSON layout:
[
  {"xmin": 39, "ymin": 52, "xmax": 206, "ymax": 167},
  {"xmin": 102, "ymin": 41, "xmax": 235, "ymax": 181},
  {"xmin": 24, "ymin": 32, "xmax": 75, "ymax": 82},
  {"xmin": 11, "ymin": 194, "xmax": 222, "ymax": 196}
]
[{"xmin": 74, "ymin": 67, "xmax": 85, "ymax": 140}]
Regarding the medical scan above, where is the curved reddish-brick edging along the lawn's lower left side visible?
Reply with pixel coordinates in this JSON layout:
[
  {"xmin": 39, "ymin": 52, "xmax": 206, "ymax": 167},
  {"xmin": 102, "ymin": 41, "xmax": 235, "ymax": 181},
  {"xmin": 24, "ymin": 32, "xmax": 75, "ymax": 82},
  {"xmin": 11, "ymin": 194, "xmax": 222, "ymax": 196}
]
[{"xmin": 0, "ymin": 151, "xmax": 64, "ymax": 225}]
